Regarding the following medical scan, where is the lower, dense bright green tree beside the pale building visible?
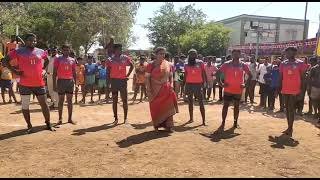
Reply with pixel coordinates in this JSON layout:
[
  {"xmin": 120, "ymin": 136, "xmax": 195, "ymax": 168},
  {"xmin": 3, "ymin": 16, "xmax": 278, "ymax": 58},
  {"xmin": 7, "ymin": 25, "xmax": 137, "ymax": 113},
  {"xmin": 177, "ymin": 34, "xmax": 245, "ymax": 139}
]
[{"xmin": 180, "ymin": 23, "xmax": 231, "ymax": 56}]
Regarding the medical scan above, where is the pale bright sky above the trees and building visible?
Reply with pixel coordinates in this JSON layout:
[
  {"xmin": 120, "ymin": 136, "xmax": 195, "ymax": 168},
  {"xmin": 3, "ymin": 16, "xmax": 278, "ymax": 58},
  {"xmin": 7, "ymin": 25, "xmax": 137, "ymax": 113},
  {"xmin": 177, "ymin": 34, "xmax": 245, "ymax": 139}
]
[{"xmin": 130, "ymin": 2, "xmax": 320, "ymax": 49}]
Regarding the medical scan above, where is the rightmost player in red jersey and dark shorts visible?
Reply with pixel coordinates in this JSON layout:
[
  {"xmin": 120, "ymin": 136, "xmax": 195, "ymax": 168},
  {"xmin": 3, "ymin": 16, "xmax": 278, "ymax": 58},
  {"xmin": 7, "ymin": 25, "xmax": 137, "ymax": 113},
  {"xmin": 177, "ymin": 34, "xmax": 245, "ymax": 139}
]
[{"xmin": 279, "ymin": 47, "xmax": 308, "ymax": 137}]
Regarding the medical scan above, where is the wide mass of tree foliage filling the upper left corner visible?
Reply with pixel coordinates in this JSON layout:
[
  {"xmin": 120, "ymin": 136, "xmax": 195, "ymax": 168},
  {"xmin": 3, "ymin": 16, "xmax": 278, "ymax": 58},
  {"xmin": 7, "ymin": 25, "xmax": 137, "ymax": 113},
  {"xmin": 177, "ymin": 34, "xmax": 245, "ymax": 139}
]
[{"xmin": 0, "ymin": 2, "xmax": 140, "ymax": 53}]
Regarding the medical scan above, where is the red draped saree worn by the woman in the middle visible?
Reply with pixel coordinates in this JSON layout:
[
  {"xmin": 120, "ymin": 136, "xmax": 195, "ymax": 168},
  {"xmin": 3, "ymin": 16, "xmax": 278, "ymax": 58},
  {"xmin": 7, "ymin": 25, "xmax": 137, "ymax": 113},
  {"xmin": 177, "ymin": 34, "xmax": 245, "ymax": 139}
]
[{"xmin": 149, "ymin": 61, "xmax": 178, "ymax": 128}]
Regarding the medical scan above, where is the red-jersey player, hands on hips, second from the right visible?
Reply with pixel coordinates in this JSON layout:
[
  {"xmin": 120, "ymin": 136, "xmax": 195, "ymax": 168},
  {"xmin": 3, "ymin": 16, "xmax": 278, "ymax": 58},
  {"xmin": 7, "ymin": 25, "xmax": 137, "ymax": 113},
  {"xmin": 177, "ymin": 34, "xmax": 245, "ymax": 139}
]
[{"xmin": 218, "ymin": 50, "xmax": 252, "ymax": 132}]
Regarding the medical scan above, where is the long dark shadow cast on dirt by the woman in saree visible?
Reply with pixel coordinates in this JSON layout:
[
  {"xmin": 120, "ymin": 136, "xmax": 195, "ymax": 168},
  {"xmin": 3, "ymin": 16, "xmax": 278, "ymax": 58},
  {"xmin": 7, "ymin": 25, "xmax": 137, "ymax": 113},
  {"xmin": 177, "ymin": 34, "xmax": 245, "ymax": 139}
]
[{"xmin": 116, "ymin": 130, "xmax": 170, "ymax": 148}]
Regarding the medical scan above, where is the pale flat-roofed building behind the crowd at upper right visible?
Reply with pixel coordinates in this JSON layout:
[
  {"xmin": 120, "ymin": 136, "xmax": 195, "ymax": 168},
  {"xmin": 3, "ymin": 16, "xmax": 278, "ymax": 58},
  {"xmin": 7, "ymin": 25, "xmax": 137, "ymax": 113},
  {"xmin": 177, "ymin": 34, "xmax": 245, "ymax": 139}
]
[{"xmin": 217, "ymin": 14, "xmax": 309, "ymax": 46}]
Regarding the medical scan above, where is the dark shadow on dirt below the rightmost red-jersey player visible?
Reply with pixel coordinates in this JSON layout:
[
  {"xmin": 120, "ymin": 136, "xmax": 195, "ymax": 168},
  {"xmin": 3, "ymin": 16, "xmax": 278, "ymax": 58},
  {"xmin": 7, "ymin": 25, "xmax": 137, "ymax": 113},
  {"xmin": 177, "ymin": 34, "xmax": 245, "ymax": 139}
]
[{"xmin": 268, "ymin": 134, "xmax": 299, "ymax": 149}]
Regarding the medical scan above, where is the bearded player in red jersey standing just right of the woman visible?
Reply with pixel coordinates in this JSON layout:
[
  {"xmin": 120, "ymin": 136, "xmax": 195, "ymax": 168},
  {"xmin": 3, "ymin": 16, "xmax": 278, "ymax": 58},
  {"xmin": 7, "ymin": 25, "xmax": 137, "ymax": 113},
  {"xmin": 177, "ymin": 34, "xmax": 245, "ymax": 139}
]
[{"xmin": 184, "ymin": 49, "xmax": 207, "ymax": 125}]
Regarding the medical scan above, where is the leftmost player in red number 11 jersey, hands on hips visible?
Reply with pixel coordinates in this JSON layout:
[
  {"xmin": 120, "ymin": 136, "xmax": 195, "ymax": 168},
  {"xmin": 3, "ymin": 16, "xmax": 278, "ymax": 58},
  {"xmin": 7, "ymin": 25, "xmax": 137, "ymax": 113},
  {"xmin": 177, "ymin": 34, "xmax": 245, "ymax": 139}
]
[{"xmin": 4, "ymin": 33, "xmax": 54, "ymax": 133}]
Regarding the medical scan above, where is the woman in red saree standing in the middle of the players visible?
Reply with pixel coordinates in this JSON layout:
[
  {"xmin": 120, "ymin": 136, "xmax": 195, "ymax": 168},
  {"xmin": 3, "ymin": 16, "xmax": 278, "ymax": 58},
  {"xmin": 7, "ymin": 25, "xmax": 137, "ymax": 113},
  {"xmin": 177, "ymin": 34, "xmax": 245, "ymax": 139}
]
[{"xmin": 146, "ymin": 47, "xmax": 178, "ymax": 132}]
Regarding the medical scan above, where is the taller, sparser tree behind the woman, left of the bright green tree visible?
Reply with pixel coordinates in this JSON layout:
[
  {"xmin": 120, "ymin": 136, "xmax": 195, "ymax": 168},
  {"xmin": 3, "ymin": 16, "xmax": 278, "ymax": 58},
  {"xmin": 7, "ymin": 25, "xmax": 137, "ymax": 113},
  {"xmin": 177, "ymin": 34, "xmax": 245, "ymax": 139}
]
[{"xmin": 145, "ymin": 3, "xmax": 206, "ymax": 54}]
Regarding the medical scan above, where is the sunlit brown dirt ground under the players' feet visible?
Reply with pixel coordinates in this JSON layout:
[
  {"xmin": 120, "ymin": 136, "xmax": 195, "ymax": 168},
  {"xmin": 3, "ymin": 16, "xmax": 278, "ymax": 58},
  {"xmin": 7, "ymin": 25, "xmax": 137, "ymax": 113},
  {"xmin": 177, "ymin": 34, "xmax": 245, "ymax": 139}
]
[{"xmin": 0, "ymin": 77, "xmax": 320, "ymax": 177}]
